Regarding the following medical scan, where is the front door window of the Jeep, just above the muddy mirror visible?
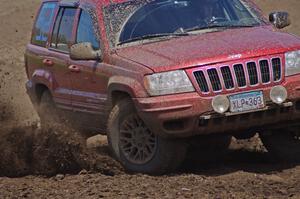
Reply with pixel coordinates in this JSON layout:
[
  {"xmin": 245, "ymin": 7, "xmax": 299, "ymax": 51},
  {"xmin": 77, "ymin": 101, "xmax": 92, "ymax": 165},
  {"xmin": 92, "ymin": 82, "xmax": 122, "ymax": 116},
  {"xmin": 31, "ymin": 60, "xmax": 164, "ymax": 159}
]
[{"xmin": 76, "ymin": 10, "xmax": 100, "ymax": 50}]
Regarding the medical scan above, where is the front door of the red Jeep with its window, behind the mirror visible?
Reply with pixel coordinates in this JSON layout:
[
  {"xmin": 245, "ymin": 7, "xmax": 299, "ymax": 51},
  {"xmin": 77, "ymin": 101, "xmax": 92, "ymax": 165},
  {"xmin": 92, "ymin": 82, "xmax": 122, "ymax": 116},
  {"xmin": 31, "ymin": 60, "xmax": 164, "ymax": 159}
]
[{"xmin": 69, "ymin": 10, "xmax": 108, "ymax": 118}]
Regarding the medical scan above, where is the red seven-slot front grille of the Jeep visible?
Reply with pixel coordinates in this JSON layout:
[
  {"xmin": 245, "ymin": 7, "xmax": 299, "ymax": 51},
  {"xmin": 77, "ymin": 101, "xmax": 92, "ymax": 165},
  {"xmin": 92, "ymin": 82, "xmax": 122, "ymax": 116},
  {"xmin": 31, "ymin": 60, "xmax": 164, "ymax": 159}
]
[{"xmin": 194, "ymin": 57, "xmax": 282, "ymax": 93}]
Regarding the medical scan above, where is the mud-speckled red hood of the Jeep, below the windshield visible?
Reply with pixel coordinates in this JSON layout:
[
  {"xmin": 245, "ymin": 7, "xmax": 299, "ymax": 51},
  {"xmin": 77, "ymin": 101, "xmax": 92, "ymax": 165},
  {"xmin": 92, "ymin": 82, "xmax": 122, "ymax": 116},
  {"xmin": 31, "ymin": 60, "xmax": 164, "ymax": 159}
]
[{"xmin": 116, "ymin": 26, "xmax": 300, "ymax": 72}]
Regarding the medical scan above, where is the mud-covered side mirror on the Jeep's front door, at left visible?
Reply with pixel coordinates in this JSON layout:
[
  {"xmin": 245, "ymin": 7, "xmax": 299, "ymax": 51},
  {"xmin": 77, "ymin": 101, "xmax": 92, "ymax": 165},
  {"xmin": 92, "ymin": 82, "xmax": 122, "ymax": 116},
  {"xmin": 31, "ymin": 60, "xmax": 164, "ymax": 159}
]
[{"xmin": 70, "ymin": 42, "xmax": 102, "ymax": 60}]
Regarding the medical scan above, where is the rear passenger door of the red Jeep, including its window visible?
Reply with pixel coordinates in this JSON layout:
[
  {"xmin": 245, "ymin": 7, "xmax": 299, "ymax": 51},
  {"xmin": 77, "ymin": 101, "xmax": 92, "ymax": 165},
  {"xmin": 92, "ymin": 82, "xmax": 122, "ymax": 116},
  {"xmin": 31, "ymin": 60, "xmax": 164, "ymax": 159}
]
[{"xmin": 44, "ymin": 7, "xmax": 77, "ymax": 109}]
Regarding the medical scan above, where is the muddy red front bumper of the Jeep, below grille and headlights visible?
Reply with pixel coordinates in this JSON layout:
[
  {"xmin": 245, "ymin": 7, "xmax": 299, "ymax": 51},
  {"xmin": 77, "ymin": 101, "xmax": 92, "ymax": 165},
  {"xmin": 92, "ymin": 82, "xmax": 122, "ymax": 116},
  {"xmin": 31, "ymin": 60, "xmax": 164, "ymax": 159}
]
[{"xmin": 134, "ymin": 75, "xmax": 300, "ymax": 137}]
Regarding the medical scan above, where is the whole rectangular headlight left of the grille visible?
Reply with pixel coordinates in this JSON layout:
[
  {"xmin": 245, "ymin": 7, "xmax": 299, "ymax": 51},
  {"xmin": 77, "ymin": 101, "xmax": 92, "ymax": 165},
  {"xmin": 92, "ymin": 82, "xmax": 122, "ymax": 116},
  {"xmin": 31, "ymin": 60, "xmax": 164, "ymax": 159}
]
[{"xmin": 145, "ymin": 70, "xmax": 195, "ymax": 96}]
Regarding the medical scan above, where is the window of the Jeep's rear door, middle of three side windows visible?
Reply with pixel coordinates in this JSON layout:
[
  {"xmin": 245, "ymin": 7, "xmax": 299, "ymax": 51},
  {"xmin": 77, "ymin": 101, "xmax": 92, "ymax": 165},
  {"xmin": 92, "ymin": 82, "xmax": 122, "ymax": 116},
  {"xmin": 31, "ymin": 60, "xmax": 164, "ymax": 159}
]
[{"xmin": 51, "ymin": 8, "xmax": 77, "ymax": 52}]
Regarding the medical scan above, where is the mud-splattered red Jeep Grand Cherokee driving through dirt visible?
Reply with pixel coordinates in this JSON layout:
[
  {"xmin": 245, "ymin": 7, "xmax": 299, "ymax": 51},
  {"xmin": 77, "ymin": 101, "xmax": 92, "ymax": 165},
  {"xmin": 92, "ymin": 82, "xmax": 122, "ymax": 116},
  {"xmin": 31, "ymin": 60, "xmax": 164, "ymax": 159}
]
[{"xmin": 25, "ymin": 0, "xmax": 300, "ymax": 174}]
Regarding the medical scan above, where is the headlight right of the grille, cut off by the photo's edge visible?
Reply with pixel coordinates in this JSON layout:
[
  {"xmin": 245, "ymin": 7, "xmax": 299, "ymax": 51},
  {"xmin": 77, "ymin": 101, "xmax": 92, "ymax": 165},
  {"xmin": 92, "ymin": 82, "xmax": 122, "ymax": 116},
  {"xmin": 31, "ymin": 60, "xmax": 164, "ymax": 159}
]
[{"xmin": 285, "ymin": 50, "xmax": 300, "ymax": 76}]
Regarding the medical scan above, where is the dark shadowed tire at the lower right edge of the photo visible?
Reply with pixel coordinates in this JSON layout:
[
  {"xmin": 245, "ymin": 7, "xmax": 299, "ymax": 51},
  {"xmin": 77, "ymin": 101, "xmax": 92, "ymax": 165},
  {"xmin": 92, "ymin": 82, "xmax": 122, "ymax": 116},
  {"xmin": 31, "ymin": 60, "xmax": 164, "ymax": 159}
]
[{"xmin": 260, "ymin": 129, "xmax": 300, "ymax": 163}]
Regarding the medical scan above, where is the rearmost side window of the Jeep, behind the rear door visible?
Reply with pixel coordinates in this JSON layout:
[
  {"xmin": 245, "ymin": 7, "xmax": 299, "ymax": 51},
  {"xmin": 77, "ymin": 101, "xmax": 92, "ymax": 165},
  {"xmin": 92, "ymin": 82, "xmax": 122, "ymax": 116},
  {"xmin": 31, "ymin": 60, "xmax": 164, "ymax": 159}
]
[{"xmin": 31, "ymin": 2, "xmax": 57, "ymax": 47}]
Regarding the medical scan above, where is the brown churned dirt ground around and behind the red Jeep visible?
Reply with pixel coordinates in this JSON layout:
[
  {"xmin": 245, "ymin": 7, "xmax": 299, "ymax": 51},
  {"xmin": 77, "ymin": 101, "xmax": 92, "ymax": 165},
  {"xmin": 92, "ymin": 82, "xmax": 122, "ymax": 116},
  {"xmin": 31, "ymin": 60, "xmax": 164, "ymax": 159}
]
[{"xmin": 0, "ymin": 0, "xmax": 300, "ymax": 198}]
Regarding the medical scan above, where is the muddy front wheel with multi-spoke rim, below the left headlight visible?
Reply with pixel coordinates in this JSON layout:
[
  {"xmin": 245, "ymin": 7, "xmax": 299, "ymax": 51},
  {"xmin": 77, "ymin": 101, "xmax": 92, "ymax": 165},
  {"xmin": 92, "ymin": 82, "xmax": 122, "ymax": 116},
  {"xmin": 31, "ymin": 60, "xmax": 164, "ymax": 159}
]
[{"xmin": 108, "ymin": 99, "xmax": 187, "ymax": 175}]
